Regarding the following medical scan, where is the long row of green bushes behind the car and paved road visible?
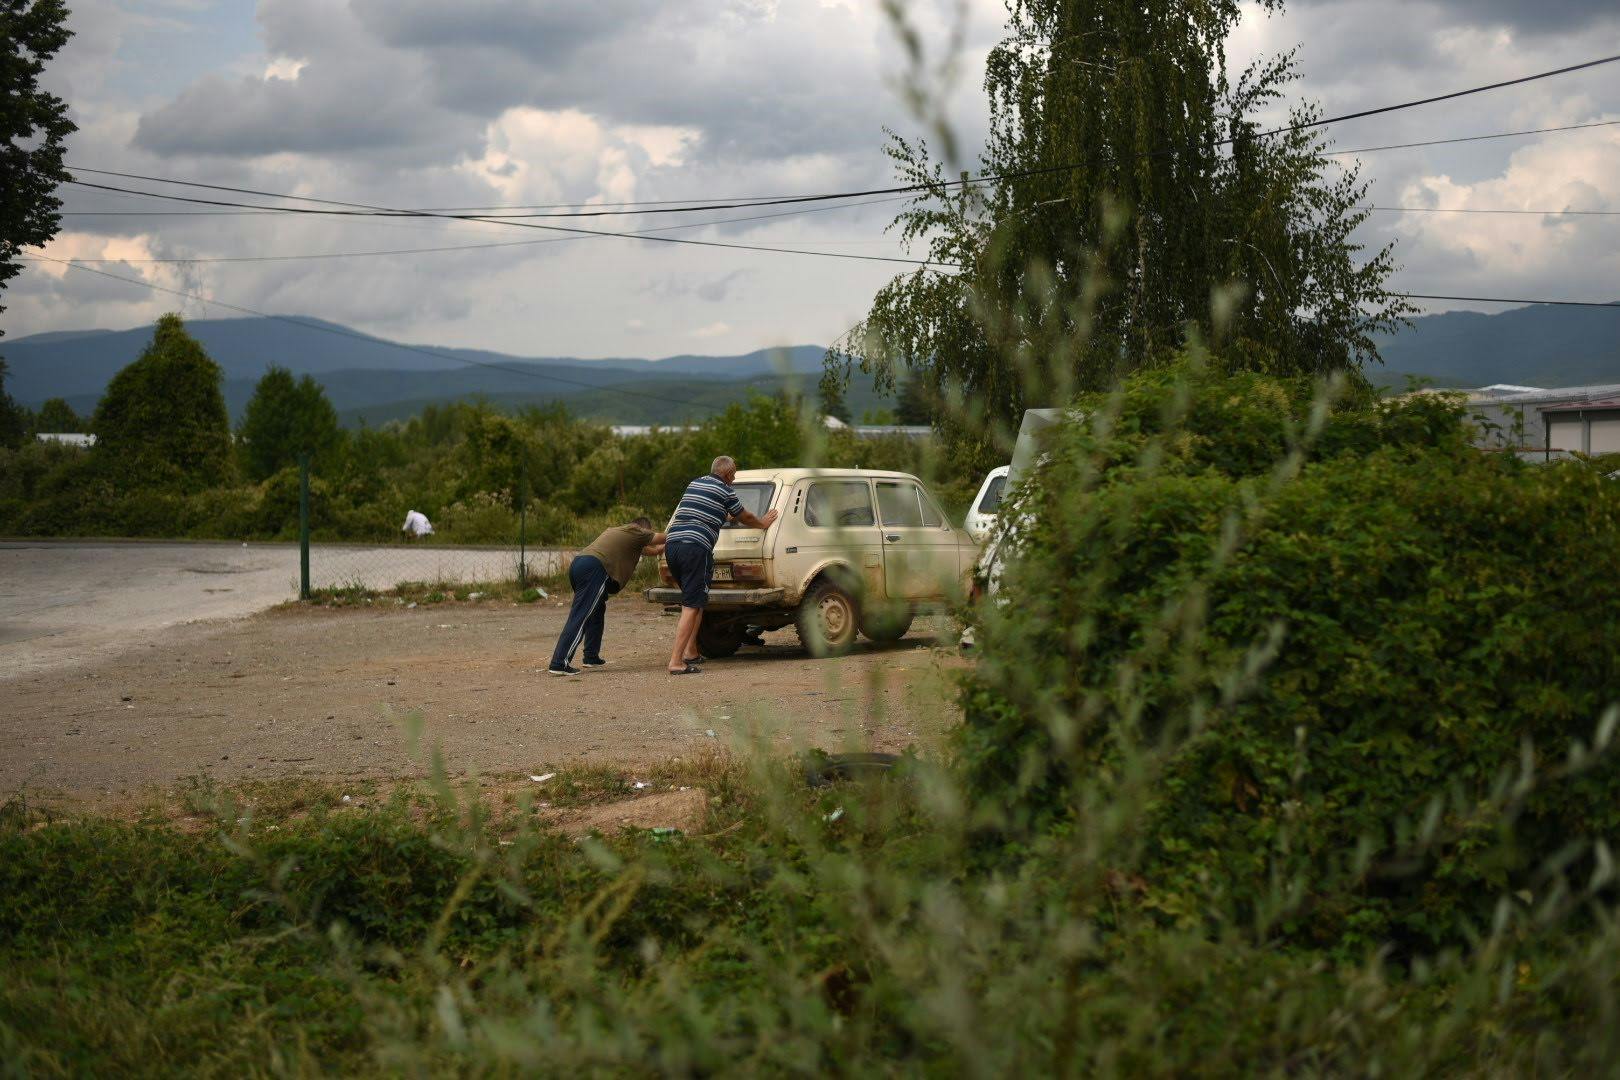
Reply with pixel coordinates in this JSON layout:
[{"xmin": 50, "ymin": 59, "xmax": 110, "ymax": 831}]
[{"xmin": 0, "ymin": 383, "xmax": 980, "ymax": 544}]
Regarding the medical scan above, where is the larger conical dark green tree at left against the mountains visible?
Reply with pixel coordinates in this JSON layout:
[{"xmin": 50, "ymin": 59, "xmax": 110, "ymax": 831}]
[{"xmin": 91, "ymin": 314, "xmax": 232, "ymax": 491}]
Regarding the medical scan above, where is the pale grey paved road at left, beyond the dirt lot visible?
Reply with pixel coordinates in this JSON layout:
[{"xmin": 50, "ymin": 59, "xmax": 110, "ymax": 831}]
[{"xmin": 0, "ymin": 541, "xmax": 557, "ymax": 682}]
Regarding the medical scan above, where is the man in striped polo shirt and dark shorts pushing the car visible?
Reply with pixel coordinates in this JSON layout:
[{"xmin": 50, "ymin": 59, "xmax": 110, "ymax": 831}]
[{"xmin": 664, "ymin": 455, "xmax": 776, "ymax": 675}]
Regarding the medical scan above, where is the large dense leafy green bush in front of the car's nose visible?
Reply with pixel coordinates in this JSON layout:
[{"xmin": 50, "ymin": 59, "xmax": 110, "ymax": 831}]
[{"xmin": 959, "ymin": 366, "xmax": 1620, "ymax": 950}]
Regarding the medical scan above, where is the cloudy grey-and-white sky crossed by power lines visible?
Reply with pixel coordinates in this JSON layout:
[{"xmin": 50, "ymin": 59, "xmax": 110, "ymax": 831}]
[{"xmin": 9, "ymin": 0, "xmax": 1620, "ymax": 356}]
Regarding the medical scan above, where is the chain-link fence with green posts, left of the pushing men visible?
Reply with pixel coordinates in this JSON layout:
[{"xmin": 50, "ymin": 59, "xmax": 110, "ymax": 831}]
[{"xmin": 298, "ymin": 460, "xmax": 569, "ymax": 597}]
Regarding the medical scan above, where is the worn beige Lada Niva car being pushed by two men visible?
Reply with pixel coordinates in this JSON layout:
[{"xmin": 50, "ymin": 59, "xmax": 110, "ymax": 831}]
[{"xmin": 646, "ymin": 468, "xmax": 978, "ymax": 656}]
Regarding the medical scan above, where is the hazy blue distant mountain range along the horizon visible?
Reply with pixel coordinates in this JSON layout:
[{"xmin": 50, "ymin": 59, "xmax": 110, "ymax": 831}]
[{"xmin": 0, "ymin": 306, "xmax": 1620, "ymax": 424}]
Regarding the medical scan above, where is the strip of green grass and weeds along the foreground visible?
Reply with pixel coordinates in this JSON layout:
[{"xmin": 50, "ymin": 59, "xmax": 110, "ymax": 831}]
[{"xmin": 0, "ymin": 758, "xmax": 1620, "ymax": 1075}]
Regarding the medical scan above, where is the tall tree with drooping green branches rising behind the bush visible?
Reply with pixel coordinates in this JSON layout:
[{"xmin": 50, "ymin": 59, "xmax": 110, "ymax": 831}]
[{"xmin": 825, "ymin": 0, "xmax": 1411, "ymax": 455}]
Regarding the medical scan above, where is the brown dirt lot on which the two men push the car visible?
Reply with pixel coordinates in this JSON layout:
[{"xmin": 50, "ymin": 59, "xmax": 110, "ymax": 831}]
[{"xmin": 0, "ymin": 597, "xmax": 964, "ymax": 800}]
